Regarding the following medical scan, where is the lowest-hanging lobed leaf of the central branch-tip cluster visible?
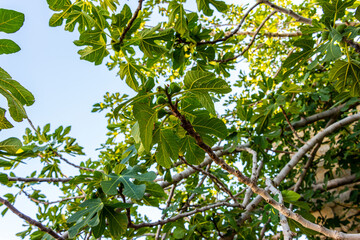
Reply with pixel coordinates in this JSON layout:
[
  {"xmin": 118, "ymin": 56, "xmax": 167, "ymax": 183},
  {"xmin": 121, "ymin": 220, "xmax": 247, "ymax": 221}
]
[{"xmin": 156, "ymin": 129, "xmax": 180, "ymax": 168}]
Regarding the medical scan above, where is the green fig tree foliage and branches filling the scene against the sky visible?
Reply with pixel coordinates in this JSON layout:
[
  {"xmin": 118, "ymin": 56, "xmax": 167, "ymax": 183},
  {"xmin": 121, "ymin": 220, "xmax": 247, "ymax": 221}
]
[{"xmin": 0, "ymin": 0, "xmax": 360, "ymax": 239}]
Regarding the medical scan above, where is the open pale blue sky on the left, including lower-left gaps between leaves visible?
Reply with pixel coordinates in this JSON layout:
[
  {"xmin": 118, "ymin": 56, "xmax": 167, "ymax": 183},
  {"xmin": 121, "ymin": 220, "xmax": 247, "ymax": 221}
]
[{"xmin": 0, "ymin": 0, "xmax": 133, "ymax": 240}]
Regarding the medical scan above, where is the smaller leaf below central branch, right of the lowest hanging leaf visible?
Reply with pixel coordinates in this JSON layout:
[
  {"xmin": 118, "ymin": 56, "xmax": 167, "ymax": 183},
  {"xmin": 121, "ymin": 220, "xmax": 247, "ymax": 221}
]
[{"xmin": 180, "ymin": 136, "xmax": 205, "ymax": 165}]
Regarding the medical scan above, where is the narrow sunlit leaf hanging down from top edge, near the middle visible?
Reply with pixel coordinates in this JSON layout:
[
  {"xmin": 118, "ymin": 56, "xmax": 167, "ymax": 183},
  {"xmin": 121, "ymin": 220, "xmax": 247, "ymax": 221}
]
[{"xmin": 168, "ymin": 1, "xmax": 189, "ymax": 35}]
